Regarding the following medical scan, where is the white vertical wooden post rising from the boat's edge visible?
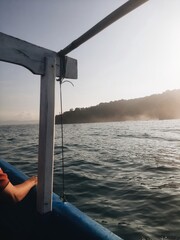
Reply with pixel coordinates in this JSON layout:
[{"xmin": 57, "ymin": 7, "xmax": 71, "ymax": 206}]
[{"xmin": 37, "ymin": 56, "xmax": 56, "ymax": 213}]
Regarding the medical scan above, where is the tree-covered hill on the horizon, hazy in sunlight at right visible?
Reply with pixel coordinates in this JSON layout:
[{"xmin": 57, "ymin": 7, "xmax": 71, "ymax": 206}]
[{"xmin": 55, "ymin": 89, "xmax": 180, "ymax": 124}]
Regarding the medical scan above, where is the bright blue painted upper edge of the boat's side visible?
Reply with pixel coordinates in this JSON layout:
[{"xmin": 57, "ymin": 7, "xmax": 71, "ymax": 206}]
[{"xmin": 0, "ymin": 159, "xmax": 123, "ymax": 240}]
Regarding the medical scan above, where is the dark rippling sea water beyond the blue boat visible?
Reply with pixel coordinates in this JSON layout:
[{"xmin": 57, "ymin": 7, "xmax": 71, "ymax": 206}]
[{"xmin": 0, "ymin": 120, "xmax": 180, "ymax": 240}]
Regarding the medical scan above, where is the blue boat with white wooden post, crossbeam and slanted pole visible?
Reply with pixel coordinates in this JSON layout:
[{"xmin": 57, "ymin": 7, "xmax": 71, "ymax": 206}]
[{"xmin": 0, "ymin": 0, "xmax": 147, "ymax": 240}]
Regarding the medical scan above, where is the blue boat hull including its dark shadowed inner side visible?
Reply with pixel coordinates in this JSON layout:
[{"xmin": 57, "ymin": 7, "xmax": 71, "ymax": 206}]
[{"xmin": 0, "ymin": 160, "xmax": 122, "ymax": 240}]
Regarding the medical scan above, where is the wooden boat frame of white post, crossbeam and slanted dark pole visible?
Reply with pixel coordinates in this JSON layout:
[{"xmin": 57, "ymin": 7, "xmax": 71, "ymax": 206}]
[{"xmin": 0, "ymin": 0, "xmax": 148, "ymax": 213}]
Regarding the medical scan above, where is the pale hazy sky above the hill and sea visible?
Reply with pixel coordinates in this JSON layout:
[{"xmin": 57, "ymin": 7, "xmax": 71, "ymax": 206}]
[{"xmin": 0, "ymin": 0, "xmax": 180, "ymax": 123}]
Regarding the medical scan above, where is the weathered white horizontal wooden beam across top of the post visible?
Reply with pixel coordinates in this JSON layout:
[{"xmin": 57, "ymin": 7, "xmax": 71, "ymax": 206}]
[{"xmin": 0, "ymin": 32, "xmax": 77, "ymax": 79}]
